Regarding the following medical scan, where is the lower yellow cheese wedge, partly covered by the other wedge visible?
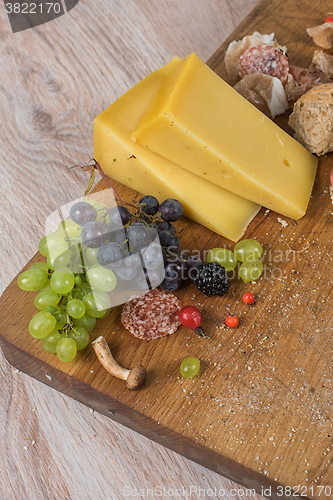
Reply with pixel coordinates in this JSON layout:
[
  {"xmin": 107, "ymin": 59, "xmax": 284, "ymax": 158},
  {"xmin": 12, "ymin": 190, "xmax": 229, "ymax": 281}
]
[{"xmin": 94, "ymin": 58, "xmax": 260, "ymax": 241}]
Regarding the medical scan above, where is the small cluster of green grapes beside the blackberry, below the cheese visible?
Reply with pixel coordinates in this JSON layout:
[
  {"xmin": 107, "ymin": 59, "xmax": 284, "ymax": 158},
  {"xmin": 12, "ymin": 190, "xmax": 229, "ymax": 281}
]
[{"xmin": 207, "ymin": 239, "xmax": 264, "ymax": 283}]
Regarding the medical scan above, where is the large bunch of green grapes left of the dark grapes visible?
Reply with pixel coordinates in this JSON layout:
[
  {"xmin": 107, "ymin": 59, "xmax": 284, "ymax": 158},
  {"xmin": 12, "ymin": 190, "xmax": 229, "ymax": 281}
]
[{"xmin": 18, "ymin": 203, "xmax": 117, "ymax": 361}]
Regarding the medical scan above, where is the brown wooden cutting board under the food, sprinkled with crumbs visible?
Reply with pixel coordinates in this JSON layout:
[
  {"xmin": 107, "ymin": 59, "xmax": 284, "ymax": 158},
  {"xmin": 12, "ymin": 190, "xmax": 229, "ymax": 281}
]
[{"xmin": 0, "ymin": 0, "xmax": 333, "ymax": 499}]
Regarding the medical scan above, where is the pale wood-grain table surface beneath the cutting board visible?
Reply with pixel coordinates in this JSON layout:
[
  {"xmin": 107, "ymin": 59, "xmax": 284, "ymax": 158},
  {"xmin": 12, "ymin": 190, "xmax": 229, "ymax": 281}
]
[{"xmin": 0, "ymin": 0, "xmax": 278, "ymax": 500}]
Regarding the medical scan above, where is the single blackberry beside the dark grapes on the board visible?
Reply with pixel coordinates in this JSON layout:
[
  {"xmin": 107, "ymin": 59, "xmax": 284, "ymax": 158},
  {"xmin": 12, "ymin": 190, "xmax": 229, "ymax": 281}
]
[{"xmin": 195, "ymin": 262, "xmax": 230, "ymax": 296}]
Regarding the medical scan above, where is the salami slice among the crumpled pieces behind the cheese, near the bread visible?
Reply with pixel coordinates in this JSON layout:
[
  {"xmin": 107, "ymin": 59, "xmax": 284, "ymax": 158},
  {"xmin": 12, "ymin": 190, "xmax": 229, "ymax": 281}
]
[{"xmin": 239, "ymin": 45, "xmax": 289, "ymax": 83}]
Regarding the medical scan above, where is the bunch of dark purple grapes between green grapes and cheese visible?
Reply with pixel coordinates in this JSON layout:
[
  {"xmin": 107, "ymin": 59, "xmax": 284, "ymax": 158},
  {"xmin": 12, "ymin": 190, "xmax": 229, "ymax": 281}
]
[{"xmin": 70, "ymin": 195, "xmax": 202, "ymax": 291}]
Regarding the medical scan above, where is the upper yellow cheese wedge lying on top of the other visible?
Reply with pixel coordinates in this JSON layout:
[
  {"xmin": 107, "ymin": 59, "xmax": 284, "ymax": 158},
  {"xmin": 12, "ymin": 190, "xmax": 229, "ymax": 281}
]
[{"xmin": 132, "ymin": 54, "xmax": 317, "ymax": 219}]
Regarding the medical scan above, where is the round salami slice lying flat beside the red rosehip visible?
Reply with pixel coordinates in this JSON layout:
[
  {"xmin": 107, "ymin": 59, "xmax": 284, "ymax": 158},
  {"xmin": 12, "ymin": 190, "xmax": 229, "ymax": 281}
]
[{"xmin": 121, "ymin": 288, "xmax": 181, "ymax": 340}]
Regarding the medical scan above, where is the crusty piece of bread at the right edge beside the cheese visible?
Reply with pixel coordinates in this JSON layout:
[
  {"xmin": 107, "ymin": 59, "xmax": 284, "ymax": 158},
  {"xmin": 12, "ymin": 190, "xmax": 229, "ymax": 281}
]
[{"xmin": 289, "ymin": 83, "xmax": 333, "ymax": 156}]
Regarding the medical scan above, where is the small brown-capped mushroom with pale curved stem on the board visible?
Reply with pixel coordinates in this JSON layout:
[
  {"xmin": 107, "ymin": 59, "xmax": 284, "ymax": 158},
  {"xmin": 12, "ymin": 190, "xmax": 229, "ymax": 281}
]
[{"xmin": 92, "ymin": 335, "xmax": 147, "ymax": 390}]
